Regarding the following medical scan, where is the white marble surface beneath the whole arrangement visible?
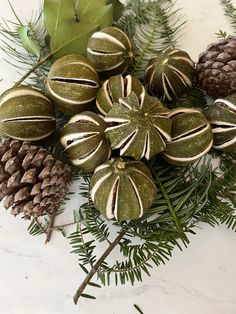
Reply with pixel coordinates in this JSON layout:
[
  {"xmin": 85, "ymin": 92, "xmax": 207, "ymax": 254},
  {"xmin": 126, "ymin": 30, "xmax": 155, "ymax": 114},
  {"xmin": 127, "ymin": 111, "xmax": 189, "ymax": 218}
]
[{"xmin": 0, "ymin": 0, "xmax": 236, "ymax": 314}]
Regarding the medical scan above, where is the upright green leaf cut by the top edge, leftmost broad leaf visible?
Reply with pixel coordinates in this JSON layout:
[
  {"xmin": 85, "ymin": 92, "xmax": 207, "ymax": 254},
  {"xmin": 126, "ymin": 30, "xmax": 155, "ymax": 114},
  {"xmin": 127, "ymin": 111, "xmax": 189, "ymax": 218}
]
[{"xmin": 43, "ymin": 0, "xmax": 75, "ymax": 36}]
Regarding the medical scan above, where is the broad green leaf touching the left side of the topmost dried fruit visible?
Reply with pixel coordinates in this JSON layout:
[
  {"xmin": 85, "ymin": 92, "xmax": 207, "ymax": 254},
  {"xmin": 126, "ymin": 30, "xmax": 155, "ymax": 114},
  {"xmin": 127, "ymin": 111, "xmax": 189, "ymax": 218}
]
[{"xmin": 50, "ymin": 21, "xmax": 98, "ymax": 59}]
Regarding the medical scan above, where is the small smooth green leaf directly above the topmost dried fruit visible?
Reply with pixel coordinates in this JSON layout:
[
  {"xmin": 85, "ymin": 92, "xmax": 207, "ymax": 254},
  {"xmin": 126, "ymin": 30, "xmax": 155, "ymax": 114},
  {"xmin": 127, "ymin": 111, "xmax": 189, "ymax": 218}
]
[{"xmin": 81, "ymin": 4, "xmax": 113, "ymax": 28}]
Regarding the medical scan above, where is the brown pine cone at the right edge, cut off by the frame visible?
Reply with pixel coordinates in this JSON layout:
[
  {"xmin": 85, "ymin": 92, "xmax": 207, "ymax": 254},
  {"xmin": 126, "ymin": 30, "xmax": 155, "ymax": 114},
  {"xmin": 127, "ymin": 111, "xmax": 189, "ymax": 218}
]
[{"xmin": 197, "ymin": 36, "xmax": 236, "ymax": 98}]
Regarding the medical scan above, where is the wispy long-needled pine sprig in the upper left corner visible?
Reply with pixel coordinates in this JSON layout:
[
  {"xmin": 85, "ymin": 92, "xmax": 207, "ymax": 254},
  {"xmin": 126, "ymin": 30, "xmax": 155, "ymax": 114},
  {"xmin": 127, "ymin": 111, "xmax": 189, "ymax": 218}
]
[{"xmin": 0, "ymin": 4, "xmax": 50, "ymax": 90}]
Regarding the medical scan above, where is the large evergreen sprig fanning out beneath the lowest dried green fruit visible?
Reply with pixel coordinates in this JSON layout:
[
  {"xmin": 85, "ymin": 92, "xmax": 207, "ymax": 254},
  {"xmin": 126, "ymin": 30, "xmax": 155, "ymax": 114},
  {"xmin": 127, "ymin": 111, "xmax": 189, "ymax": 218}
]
[{"xmin": 70, "ymin": 158, "xmax": 214, "ymax": 300}]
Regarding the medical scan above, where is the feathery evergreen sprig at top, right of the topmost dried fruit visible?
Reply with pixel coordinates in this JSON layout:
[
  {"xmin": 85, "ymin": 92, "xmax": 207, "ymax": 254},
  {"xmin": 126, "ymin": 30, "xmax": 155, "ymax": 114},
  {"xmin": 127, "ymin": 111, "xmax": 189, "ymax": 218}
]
[{"xmin": 118, "ymin": 0, "xmax": 185, "ymax": 79}]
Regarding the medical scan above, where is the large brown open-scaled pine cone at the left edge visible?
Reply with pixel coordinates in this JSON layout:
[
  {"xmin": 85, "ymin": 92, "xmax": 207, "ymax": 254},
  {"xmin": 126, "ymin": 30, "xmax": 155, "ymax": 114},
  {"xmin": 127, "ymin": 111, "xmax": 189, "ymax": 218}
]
[{"xmin": 0, "ymin": 139, "xmax": 71, "ymax": 219}]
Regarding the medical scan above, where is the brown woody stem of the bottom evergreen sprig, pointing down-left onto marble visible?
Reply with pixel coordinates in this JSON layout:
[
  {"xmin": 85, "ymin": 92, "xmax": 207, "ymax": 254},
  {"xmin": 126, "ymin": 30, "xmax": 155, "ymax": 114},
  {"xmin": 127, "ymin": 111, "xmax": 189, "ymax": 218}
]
[{"xmin": 73, "ymin": 230, "xmax": 126, "ymax": 304}]
